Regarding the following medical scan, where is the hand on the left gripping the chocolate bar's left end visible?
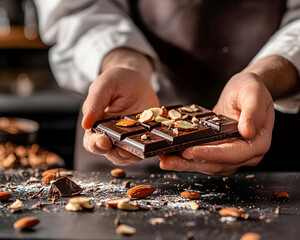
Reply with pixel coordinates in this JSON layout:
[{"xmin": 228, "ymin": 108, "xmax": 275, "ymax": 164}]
[{"xmin": 82, "ymin": 67, "xmax": 159, "ymax": 165}]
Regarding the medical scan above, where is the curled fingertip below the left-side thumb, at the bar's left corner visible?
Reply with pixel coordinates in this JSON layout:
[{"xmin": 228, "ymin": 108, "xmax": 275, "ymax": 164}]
[{"xmin": 83, "ymin": 130, "xmax": 112, "ymax": 155}]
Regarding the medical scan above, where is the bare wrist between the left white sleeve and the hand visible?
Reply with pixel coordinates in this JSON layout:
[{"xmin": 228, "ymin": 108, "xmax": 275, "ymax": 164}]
[{"xmin": 100, "ymin": 48, "xmax": 153, "ymax": 80}]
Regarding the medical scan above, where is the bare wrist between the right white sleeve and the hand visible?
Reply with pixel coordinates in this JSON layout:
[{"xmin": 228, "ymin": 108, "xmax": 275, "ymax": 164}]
[{"xmin": 243, "ymin": 55, "xmax": 298, "ymax": 99}]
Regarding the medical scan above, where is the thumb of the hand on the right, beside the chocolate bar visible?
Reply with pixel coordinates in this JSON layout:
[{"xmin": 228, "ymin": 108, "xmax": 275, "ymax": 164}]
[{"xmin": 237, "ymin": 81, "xmax": 272, "ymax": 139}]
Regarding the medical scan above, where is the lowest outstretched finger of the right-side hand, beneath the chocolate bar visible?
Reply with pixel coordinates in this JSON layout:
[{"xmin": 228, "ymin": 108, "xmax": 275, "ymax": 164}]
[{"xmin": 159, "ymin": 155, "xmax": 238, "ymax": 175}]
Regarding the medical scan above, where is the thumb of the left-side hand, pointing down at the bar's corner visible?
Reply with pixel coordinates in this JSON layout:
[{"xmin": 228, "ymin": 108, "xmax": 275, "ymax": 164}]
[{"xmin": 81, "ymin": 75, "xmax": 113, "ymax": 129}]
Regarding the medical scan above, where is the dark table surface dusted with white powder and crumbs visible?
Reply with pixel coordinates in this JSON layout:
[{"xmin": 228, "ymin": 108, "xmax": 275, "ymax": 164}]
[{"xmin": 0, "ymin": 169, "xmax": 300, "ymax": 240}]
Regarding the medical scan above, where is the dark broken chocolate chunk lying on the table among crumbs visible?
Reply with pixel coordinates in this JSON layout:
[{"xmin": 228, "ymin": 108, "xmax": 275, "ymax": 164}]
[{"xmin": 48, "ymin": 177, "xmax": 83, "ymax": 197}]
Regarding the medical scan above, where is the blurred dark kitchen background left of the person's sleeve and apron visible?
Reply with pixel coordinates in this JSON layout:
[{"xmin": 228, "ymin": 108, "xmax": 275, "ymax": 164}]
[{"xmin": 0, "ymin": 0, "xmax": 81, "ymax": 168}]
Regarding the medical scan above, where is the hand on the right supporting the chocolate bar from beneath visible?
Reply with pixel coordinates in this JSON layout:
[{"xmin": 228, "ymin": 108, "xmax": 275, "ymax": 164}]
[{"xmin": 159, "ymin": 72, "xmax": 274, "ymax": 175}]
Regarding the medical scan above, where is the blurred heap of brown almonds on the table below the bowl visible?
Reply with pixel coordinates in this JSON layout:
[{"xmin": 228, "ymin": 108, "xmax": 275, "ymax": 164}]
[{"xmin": 0, "ymin": 142, "xmax": 61, "ymax": 169}]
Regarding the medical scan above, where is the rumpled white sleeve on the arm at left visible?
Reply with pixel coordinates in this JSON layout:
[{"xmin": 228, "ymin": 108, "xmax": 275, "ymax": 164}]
[{"xmin": 35, "ymin": 0, "xmax": 158, "ymax": 94}]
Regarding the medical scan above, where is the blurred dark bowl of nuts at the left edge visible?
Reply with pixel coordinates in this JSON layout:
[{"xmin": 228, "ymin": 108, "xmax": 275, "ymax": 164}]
[{"xmin": 0, "ymin": 117, "xmax": 39, "ymax": 145}]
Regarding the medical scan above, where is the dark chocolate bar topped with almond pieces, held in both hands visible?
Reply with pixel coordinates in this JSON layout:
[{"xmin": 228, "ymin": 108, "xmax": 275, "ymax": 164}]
[{"xmin": 93, "ymin": 104, "xmax": 240, "ymax": 159}]
